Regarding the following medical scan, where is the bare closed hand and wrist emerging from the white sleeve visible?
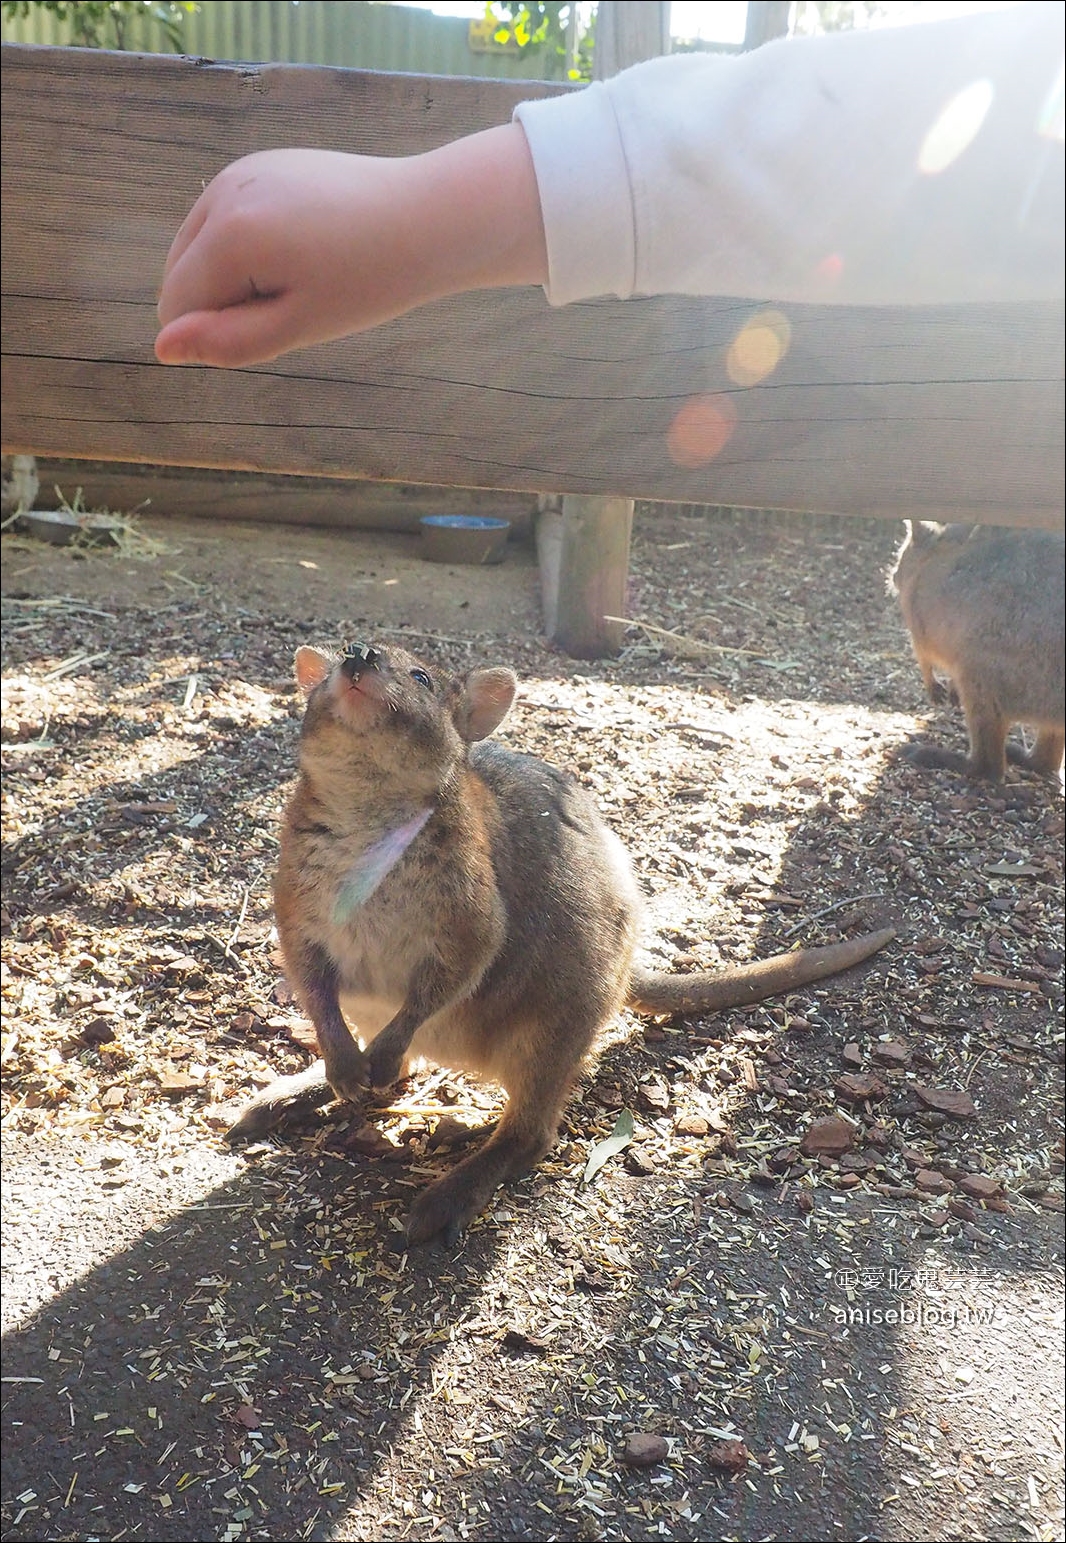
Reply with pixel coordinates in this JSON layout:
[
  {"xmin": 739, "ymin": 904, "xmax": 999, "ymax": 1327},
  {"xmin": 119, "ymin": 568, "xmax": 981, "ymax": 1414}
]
[{"xmin": 156, "ymin": 123, "xmax": 548, "ymax": 366}]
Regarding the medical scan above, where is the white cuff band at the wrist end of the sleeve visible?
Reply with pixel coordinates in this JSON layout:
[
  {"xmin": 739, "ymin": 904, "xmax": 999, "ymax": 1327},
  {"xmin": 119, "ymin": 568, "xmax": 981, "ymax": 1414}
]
[{"xmin": 514, "ymin": 82, "xmax": 637, "ymax": 306}]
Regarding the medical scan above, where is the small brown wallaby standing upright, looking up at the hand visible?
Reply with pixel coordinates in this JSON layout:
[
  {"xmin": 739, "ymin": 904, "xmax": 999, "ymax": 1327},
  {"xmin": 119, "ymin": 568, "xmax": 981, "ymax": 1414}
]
[{"xmin": 230, "ymin": 645, "xmax": 893, "ymax": 1241}]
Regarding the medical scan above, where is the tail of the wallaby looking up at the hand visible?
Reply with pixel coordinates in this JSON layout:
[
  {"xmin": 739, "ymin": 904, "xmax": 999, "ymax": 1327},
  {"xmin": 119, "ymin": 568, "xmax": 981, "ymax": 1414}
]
[{"xmin": 628, "ymin": 927, "xmax": 896, "ymax": 1014}]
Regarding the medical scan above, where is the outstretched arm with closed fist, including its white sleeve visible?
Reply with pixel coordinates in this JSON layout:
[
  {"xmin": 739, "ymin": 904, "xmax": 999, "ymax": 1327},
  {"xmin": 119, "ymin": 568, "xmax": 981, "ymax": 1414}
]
[{"xmin": 156, "ymin": 3, "xmax": 1066, "ymax": 366}]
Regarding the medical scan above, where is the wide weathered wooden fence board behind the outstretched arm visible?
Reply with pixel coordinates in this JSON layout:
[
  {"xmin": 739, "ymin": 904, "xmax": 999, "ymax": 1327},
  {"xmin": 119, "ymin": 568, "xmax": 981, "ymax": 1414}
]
[{"xmin": 2, "ymin": 45, "xmax": 1063, "ymax": 528}]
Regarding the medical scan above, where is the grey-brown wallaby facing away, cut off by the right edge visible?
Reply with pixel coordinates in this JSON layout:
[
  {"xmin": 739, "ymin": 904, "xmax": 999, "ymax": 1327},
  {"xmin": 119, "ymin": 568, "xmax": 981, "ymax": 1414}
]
[{"xmin": 890, "ymin": 520, "xmax": 1064, "ymax": 782}]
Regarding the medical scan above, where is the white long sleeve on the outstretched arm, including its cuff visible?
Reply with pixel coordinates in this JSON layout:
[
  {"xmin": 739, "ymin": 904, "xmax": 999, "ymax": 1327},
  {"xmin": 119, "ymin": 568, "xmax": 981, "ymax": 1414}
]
[{"xmin": 515, "ymin": 3, "xmax": 1064, "ymax": 306}]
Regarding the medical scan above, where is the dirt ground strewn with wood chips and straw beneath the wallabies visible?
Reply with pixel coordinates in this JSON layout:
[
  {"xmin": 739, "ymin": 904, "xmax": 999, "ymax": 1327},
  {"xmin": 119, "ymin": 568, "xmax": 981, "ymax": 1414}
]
[{"xmin": 2, "ymin": 511, "xmax": 1063, "ymax": 1543}]
